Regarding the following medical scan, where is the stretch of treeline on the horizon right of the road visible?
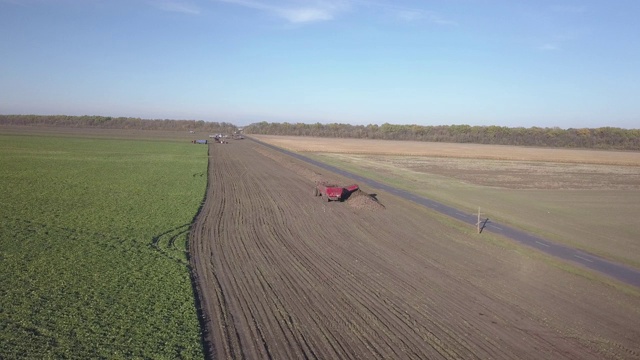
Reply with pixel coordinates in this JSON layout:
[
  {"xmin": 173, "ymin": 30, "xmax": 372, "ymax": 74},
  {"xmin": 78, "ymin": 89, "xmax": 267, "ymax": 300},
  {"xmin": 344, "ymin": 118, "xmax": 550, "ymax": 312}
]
[{"xmin": 244, "ymin": 122, "xmax": 640, "ymax": 151}]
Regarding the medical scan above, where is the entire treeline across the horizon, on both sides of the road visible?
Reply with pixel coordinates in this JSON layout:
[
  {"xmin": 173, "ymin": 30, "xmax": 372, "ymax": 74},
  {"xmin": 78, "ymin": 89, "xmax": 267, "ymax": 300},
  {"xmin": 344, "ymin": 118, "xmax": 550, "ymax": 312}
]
[{"xmin": 0, "ymin": 115, "xmax": 640, "ymax": 151}]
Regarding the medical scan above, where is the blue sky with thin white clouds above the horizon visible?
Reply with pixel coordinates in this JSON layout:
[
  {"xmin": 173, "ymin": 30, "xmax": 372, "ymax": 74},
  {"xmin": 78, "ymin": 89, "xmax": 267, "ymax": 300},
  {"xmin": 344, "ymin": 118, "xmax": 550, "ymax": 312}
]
[{"xmin": 0, "ymin": 0, "xmax": 640, "ymax": 128}]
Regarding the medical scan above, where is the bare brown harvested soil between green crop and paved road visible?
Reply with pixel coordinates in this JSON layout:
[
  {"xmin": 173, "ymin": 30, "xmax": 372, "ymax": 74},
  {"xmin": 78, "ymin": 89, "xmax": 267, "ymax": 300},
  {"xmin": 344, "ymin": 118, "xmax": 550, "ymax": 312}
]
[{"xmin": 190, "ymin": 141, "xmax": 640, "ymax": 359}]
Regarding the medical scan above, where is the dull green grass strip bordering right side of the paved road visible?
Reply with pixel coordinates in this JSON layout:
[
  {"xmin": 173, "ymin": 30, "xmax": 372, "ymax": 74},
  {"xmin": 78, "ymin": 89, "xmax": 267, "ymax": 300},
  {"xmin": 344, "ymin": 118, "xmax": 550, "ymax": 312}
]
[{"xmin": 305, "ymin": 153, "xmax": 640, "ymax": 267}]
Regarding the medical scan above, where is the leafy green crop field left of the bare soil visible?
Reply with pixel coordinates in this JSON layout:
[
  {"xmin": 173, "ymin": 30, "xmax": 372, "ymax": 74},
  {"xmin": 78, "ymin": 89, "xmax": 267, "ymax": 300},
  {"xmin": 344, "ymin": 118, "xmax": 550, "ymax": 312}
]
[{"xmin": 0, "ymin": 129, "xmax": 207, "ymax": 359}]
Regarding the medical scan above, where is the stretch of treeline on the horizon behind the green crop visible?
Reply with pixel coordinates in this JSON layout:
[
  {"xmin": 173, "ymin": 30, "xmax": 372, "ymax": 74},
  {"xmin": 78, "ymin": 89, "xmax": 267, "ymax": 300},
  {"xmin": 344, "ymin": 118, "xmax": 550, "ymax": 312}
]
[{"xmin": 0, "ymin": 115, "xmax": 238, "ymax": 133}]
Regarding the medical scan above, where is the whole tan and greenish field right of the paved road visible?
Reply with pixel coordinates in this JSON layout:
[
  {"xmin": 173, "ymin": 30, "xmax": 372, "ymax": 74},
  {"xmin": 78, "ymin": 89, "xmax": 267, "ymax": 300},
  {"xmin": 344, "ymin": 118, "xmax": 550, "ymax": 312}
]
[{"xmin": 255, "ymin": 135, "xmax": 640, "ymax": 267}]
